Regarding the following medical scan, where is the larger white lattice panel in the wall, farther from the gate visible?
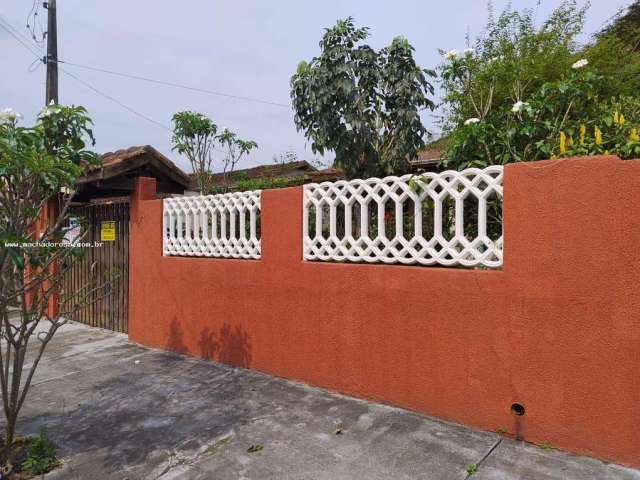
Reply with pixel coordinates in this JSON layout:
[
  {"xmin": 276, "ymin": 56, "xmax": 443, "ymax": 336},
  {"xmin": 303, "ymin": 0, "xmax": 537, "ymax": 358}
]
[{"xmin": 303, "ymin": 166, "xmax": 503, "ymax": 267}]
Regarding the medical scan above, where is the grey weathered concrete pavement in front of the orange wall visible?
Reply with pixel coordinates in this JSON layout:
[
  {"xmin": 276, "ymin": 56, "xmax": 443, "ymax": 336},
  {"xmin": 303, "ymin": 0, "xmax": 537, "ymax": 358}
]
[{"xmin": 10, "ymin": 325, "xmax": 640, "ymax": 480}]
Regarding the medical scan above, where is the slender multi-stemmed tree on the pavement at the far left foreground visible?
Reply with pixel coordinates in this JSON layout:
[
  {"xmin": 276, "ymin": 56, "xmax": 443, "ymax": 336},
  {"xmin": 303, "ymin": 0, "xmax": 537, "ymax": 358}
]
[{"xmin": 0, "ymin": 105, "xmax": 98, "ymax": 462}]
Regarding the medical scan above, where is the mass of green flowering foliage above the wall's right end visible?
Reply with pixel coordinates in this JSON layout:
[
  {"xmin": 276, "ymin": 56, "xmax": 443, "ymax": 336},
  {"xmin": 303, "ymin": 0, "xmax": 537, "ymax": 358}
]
[{"xmin": 439, "ymin": 1, "xmax": 639, "ymax": 169}]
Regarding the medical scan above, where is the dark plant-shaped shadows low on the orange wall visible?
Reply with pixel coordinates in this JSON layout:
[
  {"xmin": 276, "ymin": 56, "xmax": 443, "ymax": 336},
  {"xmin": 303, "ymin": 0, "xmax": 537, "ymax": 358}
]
[{"xmin": 167, "ymin": 317, "xmax": 251, "ymax": 368}]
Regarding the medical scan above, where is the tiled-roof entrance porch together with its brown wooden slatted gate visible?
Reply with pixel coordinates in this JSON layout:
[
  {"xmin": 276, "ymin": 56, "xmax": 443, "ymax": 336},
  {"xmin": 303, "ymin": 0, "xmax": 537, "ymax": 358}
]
[{"xmin": 62, "ymin": 145, "xmax": 189, "ymax": 332}]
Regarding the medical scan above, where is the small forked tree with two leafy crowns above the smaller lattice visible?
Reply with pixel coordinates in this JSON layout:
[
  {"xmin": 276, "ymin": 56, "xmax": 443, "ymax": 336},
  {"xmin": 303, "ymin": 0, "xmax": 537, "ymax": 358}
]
[{"xmin": 171, "ymin": 111, "xmax": 258, "ymax": 195}]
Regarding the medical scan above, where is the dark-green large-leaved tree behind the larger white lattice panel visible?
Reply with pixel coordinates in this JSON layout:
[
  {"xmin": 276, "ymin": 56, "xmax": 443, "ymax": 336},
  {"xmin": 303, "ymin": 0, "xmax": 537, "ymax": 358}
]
[{"xmin": 291, "ymin": 18, "xmax": 434, "ymax": 177}]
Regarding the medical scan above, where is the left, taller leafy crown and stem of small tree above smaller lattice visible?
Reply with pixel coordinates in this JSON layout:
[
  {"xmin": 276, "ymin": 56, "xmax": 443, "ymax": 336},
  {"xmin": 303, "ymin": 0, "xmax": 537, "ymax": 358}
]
[{"xmin": 171, "ymin": 111, "xmax": 218, "ymax": 193}]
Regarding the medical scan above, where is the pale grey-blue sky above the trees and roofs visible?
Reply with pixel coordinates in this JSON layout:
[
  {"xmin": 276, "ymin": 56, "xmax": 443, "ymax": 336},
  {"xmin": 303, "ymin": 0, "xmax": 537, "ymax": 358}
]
[{"xmin": 0, "ymin": 0, "xmax": 631, "ymax": 171}]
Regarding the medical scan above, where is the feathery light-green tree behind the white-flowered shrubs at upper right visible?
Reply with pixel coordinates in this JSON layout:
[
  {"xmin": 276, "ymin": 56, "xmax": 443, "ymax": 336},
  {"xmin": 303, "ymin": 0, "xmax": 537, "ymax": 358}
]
[{"xmin": 439, "ymin": 2, "xmax": 585, "ymax": 131}]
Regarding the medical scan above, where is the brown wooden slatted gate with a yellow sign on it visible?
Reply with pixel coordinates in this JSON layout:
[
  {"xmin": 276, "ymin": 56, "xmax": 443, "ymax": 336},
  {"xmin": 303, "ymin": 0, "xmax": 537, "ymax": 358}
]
[{"xmin": 63, "ymin": 200, "xmax": 129, "ymax": 333}]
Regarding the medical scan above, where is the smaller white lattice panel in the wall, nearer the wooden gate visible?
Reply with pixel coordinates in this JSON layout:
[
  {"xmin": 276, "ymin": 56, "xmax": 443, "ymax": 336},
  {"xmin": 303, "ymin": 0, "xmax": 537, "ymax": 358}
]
[{"xmin": 162, "ymin": 190, "xmax": 260, "ymax": 259}]
